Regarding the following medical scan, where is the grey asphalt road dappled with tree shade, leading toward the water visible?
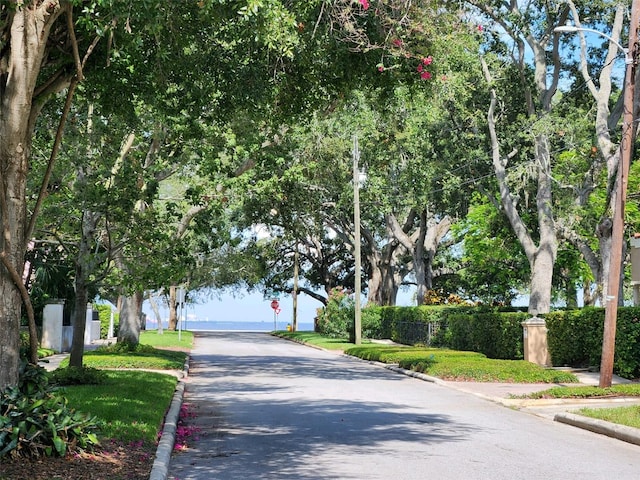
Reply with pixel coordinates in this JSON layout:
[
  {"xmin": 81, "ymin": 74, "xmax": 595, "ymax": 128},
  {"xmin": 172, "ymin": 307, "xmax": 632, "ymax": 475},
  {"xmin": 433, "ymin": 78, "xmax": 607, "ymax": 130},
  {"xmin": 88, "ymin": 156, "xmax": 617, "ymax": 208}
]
[{"xmin": 169, "ymin": 332, "xmax": 640, "ymax": 480}]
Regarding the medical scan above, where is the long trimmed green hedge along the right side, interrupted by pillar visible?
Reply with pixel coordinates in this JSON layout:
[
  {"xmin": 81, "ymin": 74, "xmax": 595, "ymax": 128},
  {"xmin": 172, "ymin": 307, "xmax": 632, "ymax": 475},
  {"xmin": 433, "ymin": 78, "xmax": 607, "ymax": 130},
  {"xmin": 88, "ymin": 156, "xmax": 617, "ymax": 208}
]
[{"xmin": 317, "ymin": 300, "xmax": 640, "ymax": 378}]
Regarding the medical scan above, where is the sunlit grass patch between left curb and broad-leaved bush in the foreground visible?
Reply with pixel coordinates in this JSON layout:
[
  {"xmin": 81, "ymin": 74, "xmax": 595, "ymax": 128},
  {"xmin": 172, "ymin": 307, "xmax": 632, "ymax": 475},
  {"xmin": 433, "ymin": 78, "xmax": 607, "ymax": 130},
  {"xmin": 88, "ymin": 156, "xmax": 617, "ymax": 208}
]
[{"xmin": 63, "ymin": 370, "xmax": 177, "ymax": 444}]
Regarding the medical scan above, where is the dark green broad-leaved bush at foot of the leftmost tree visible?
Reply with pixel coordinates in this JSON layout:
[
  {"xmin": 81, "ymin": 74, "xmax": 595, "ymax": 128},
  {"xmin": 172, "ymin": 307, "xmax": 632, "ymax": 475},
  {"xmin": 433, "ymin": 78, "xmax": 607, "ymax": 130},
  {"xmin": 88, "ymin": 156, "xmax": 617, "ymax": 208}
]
[{"xmin": 0, "ymin": 362, "xmax": 99, "ymax": 458}]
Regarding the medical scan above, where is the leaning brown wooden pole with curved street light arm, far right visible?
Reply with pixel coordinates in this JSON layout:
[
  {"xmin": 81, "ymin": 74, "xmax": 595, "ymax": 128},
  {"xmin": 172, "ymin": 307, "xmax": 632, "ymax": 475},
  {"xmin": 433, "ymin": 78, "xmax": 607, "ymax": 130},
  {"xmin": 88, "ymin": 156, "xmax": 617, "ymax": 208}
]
[{"xmin": 555, "ymin": 8, "xmax": 640, "ymax": 388}]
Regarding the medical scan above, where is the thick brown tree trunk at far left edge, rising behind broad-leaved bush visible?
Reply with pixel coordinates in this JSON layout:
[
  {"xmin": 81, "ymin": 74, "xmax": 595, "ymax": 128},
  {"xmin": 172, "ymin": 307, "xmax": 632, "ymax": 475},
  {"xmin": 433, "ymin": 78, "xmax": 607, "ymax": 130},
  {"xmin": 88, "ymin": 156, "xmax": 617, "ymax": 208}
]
[{"xmin": 0, "ymin": 0, "xmax": 60, "ymax": 391}]
